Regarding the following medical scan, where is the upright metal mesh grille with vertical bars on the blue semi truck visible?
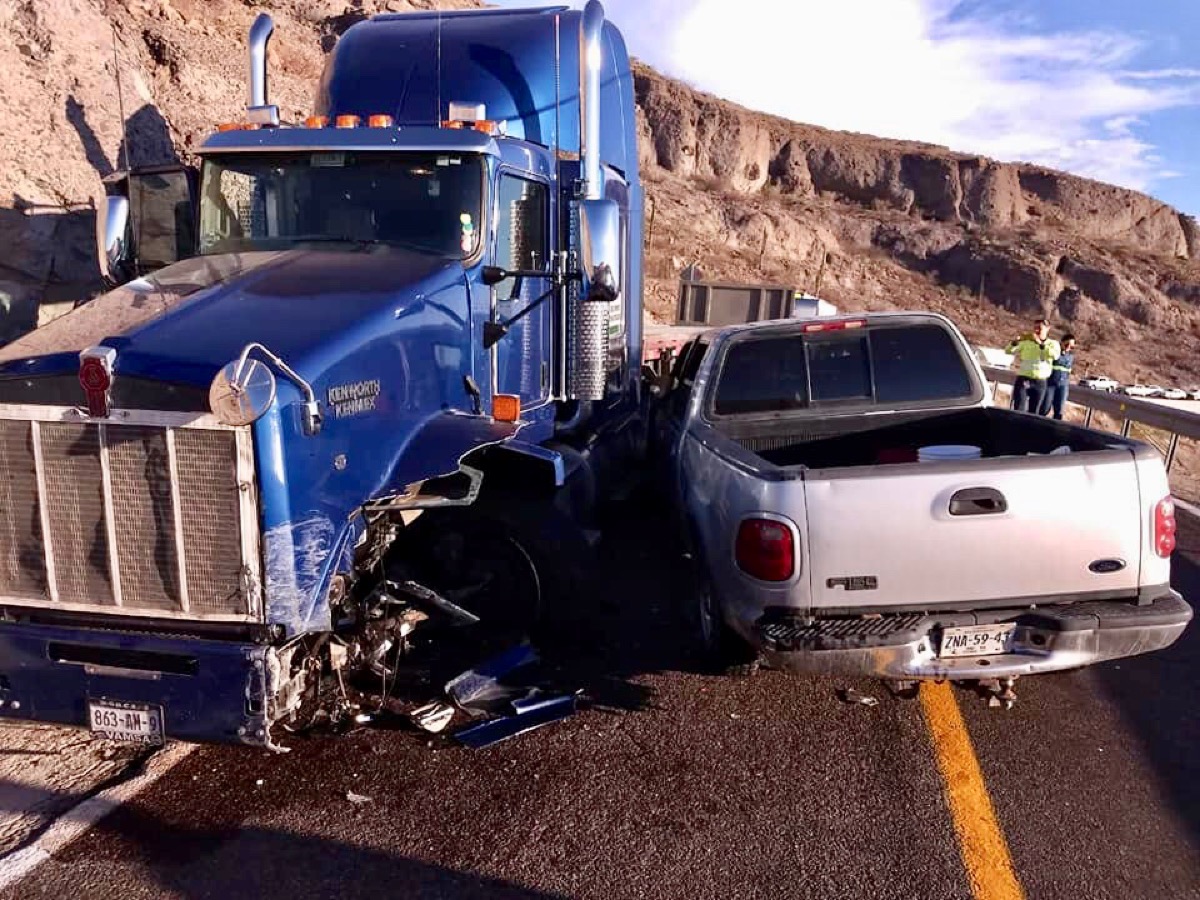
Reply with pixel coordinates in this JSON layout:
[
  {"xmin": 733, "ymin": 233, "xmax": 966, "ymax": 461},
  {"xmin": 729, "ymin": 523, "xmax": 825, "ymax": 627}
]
[{"xmin": 0, "ymin": 415, "xmax": 262, "ymax": 620}]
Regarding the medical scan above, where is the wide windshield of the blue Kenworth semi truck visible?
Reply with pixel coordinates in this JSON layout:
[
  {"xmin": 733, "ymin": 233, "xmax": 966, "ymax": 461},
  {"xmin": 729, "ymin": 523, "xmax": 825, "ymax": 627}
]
[{"xmin": 199, "ymin": 151, "xmax": 485, "ymax": 259}]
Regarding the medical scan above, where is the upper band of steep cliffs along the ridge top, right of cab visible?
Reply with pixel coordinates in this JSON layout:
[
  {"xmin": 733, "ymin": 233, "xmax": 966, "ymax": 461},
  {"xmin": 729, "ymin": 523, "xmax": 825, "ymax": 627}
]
[{"xmin": 637, "ymin": 67, "xmax": 1195, "ymax": 257}]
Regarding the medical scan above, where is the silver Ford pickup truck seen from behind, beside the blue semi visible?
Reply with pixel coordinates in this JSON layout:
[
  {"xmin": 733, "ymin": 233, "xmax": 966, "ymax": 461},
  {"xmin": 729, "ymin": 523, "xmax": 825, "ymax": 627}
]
[{"xmin": 652, "ymin": 313, "xmax": 1192, "ymax": 682}]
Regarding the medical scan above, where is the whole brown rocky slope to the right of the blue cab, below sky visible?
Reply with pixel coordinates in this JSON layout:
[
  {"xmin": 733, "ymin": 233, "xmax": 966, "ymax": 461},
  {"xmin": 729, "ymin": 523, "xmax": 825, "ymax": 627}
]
[{"xmin": 636, "ymin": 66, "xmax": 1200, "ymax": 384}]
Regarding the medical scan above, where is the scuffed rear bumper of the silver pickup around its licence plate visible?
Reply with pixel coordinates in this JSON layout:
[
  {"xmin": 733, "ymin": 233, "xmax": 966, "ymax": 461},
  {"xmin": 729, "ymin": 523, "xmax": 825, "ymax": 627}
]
[{"xmin": 754, "ymin": 589, "xmax": 1192, "ymax": 680}]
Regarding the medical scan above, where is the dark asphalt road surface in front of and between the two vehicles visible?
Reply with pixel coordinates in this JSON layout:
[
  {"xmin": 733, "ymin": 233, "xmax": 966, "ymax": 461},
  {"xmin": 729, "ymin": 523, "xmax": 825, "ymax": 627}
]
[{"xmin": 2, "ymin": 508, "xmax": 1200, "ymax": 900}]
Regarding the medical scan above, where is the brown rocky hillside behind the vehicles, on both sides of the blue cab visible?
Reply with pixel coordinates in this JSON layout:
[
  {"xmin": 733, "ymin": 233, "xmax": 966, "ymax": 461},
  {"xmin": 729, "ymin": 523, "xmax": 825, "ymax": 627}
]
[{"xmin": 0, "ymin": 0, "xmax": 1200, "ymax": 385}]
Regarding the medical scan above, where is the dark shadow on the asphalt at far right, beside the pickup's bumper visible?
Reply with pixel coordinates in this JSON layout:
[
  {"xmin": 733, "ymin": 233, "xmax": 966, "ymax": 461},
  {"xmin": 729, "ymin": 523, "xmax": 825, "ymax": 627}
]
[{"xmin": 1096, "ymin": 554, "xmax": 1200, "ymax": 842}]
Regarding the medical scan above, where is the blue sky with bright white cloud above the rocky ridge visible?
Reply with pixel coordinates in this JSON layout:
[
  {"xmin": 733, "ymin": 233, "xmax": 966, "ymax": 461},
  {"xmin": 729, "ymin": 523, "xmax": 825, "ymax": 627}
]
[{"xmin": 489, "ymin": 0, "xmax": 1200, "ymax": 215}]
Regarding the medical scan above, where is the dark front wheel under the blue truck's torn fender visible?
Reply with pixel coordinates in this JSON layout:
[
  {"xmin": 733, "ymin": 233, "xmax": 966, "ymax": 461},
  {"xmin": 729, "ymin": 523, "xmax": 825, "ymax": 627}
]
[{"xmin": 400, "ymin": 493, "xmax": 594, "ymax": 632}]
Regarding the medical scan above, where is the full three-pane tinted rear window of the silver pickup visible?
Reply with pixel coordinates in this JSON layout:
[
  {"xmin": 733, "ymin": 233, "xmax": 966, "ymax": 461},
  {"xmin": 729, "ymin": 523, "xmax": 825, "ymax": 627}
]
[{"xmin": 713, "ymin": 324, "xmax": 974, "ymax": 415}]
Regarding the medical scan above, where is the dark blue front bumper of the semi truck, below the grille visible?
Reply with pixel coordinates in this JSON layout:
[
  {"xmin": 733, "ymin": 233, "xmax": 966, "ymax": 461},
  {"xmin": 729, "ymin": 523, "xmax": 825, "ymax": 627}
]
[{"xmin": 0, "ymin": 623, "xmax": 275, "ymax": 748}]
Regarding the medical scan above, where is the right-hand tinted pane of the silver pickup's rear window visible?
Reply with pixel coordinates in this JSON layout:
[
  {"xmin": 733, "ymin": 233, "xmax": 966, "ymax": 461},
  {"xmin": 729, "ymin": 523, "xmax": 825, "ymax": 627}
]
[{"xmin": 871, "ymin": 325, "xmax": 972, "ymax": 403}]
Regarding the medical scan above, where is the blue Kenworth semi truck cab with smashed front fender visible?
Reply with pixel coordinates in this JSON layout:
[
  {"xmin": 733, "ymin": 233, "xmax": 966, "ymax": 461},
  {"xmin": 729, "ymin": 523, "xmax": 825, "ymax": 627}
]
[{"xmin": 0, "ymin": 0, "xmax": 643, "ymax": 748}]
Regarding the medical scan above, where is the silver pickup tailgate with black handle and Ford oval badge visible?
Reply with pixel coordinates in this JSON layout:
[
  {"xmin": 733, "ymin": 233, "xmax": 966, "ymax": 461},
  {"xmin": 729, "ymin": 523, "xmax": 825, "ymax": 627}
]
[{"xmin": 804, "ymin": 450, "xmax": 1142, "ymax": 608}]
